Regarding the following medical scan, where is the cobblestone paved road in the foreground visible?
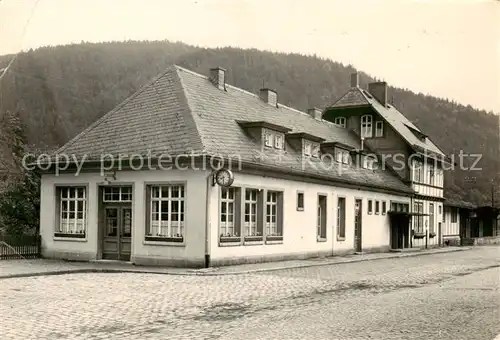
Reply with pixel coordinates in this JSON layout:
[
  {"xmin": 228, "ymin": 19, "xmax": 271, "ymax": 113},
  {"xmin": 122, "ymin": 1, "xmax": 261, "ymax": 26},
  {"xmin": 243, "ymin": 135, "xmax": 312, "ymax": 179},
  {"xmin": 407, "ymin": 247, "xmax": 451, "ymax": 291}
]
[{"xmin": 0, "ymin": 247, "xmax": 500, "ymax": 340}]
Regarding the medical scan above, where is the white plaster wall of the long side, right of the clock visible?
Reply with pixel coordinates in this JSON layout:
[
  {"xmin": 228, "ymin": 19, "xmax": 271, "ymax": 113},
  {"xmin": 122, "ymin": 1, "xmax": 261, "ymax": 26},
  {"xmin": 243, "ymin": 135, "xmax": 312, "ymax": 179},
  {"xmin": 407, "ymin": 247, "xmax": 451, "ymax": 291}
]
[{"xmin": 210, "ymin": 173, "xmax": 410, "ymax": 260}]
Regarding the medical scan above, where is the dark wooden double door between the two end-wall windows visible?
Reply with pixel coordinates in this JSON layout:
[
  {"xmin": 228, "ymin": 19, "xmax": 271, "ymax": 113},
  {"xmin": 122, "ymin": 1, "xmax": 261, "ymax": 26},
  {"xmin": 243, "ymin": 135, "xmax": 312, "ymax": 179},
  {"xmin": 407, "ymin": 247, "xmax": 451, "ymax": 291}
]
[{"xmin": 102, "ymin": 206, "xmax": 132, "ymax": 261}]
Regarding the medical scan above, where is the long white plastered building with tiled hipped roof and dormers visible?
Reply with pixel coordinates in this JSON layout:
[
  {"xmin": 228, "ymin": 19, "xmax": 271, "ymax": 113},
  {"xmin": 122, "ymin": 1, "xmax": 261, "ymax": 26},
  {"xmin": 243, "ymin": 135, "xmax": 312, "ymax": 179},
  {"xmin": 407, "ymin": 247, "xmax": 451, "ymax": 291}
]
[{"xmin": 39, "ymin": 66, "xmax": 452, "ymax": 267}]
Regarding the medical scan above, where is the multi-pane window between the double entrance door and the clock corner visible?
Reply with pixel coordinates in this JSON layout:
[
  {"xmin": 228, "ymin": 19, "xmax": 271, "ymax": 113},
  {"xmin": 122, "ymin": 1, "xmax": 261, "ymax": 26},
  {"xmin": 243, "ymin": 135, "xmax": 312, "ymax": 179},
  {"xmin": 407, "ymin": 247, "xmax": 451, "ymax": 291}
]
[{"xmin": 146, "ymin": 184, "xmax": 185, "ymax": 242}]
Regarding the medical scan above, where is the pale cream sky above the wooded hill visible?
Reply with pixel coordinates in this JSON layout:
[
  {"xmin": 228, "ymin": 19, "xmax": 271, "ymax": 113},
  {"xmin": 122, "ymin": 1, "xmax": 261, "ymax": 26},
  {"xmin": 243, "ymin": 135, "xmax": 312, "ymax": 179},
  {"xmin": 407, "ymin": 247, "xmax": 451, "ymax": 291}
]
[{"xmin": 0, "ymin": 0, "xmax": 500, "ymax": 113}]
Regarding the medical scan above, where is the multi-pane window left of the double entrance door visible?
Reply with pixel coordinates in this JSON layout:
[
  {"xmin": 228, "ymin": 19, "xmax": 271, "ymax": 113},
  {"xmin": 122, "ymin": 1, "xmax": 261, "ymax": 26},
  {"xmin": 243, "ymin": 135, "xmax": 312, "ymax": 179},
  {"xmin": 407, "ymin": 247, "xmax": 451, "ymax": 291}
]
[{"xmin": 54, "ymin": 187, "xmax": 87, "ymax": 238}]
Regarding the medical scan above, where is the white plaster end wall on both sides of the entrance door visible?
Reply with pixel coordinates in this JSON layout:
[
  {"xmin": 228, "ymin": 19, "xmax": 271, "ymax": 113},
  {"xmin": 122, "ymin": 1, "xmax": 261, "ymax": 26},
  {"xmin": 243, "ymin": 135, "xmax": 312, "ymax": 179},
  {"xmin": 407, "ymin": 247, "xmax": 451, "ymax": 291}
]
[{"xmin": 40, "ymin": 170, "xmax": 208, "ymax": 260}]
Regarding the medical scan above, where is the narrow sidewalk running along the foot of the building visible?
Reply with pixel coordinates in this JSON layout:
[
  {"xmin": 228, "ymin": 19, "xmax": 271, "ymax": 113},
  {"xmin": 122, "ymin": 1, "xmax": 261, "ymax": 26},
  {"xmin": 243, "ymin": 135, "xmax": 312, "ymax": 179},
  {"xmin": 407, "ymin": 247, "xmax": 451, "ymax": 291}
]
[{"xmin": 0, "ymin": 247, "xmax": 471, "ymax": 279}]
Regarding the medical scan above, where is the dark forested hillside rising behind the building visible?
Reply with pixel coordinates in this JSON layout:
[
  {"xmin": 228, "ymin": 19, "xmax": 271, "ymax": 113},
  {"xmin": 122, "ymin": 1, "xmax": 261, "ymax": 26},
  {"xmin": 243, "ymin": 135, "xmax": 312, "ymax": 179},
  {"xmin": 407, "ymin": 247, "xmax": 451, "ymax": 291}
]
[{"xmin": 0, "ymin": 41, "xmax": 500, "ymax": 203}]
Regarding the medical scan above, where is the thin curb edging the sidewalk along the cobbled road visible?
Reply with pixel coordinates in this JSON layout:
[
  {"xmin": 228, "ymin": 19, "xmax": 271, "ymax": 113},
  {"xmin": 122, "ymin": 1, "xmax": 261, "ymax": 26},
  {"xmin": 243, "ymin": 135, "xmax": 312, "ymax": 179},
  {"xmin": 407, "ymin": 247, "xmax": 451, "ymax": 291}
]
[{"xmin": 0, "ymin": 248, "xmax": 472, "ymax": 280}]
